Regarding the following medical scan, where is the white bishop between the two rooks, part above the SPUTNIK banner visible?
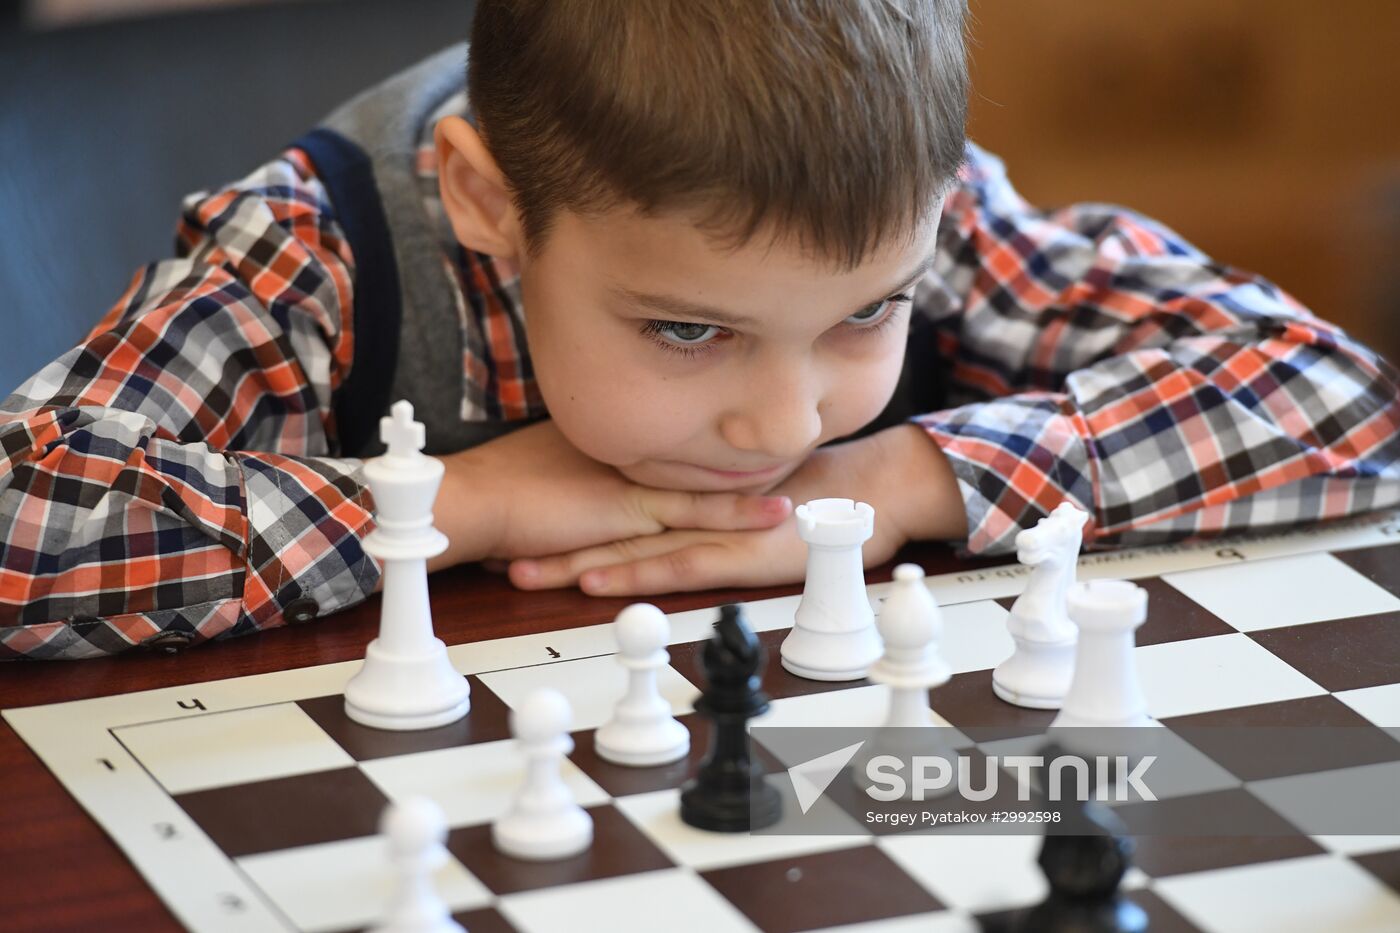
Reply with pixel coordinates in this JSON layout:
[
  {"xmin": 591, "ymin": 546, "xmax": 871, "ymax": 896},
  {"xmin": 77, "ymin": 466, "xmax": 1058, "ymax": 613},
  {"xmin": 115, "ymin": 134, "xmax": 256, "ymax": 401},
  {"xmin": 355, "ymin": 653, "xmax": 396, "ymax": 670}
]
[{"xmin": 869, "ymin": 563, "xmax": 952, "ymax": 728}]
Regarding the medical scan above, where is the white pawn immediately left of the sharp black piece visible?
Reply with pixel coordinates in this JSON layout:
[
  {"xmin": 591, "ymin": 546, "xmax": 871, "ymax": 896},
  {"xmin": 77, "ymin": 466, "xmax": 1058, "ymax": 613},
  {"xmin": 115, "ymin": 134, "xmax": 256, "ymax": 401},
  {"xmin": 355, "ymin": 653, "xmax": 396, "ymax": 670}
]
[{"xmin": 594, "ymin": 602, "xmax": 690, "ymax": 768}]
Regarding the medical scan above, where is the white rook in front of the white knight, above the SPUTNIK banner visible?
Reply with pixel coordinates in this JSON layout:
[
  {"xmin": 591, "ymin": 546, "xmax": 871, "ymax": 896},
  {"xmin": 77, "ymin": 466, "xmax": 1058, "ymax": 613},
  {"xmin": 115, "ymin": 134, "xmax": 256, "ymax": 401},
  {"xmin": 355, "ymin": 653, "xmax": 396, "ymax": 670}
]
[{"xmin": 1050, "ymin": 580, "xmax": 1154, "ymax": 728}]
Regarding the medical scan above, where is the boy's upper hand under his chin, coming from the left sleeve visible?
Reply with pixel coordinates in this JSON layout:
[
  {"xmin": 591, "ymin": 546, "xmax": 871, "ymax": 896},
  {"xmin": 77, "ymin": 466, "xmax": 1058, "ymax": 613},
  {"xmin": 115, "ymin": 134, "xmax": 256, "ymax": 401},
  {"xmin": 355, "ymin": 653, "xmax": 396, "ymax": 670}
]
[{"xmin": 428, "ymin": 420, "xmax": 792, "ymax": 570}]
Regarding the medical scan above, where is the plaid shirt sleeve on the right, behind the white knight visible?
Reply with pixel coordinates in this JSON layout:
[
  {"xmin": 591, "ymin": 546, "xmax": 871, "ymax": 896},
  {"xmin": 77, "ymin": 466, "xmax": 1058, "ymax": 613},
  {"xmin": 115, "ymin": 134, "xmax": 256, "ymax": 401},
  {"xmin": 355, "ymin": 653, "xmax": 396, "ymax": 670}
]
[{"xmin": 914, "ymin": 146, "xmax": 1400, "ymax": 553}]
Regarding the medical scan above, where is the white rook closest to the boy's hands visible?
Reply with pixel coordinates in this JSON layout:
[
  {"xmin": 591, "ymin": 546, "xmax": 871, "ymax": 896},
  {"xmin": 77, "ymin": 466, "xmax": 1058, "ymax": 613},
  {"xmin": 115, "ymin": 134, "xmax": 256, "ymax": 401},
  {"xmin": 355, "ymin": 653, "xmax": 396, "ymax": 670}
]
[{"xmin": 781, "ymin": 499, "xmax": 882, "ymax": 681}]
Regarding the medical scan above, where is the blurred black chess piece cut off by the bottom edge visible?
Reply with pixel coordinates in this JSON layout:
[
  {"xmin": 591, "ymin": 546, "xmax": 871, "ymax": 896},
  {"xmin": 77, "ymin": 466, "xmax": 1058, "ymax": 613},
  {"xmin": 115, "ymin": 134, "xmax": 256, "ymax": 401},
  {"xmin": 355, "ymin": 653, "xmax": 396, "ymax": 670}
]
[{"xmin": 1015, "ymin": 745, "xmax": 1148, "ymax": 933}]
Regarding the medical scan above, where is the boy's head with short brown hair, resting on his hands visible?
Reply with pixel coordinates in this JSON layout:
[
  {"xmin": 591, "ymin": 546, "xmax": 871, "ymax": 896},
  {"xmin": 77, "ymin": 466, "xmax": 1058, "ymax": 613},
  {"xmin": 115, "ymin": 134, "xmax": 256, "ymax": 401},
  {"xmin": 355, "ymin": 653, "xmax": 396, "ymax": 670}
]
[{"xmin": 438, "ymin": 0, "xmax": 967, "ymax": 489}]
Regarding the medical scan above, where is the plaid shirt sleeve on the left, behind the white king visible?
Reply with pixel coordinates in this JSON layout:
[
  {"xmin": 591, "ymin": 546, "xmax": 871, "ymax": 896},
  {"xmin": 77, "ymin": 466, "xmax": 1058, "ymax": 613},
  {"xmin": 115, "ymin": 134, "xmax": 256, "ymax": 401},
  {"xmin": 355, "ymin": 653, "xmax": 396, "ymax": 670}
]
[{"xmin": 0, "ymin": 148, "xmax": 378, "ymax": 658}]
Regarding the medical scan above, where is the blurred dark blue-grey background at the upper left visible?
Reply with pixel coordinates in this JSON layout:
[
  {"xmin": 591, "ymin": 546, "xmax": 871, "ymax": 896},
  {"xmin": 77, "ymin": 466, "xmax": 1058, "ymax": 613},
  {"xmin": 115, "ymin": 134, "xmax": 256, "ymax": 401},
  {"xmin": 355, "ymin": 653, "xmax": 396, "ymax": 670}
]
[{"xmin": 0, "ymin": 0, "xmax": 472, "ymax": 396}]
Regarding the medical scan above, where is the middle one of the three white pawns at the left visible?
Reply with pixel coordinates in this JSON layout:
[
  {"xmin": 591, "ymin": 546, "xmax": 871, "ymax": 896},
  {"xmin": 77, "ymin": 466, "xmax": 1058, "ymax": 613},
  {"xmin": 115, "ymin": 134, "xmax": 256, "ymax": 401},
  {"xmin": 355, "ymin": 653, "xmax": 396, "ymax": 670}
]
[{"xmin": 491, "ymin": 688, "xmax": 594, "ymax": 860}]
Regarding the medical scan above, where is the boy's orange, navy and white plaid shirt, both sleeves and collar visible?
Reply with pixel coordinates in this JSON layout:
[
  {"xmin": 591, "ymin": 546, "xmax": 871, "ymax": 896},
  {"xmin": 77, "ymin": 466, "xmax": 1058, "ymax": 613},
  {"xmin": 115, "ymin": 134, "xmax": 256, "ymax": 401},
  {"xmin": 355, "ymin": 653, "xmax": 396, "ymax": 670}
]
[{"xmin": 0, "ymin": 97, "xmax": 1400, "ymax": 658}]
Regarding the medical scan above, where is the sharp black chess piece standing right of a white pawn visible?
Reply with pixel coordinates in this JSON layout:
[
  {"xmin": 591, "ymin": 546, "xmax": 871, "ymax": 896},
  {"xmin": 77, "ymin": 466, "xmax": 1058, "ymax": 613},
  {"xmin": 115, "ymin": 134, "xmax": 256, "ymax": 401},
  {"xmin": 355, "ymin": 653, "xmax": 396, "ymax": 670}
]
[{"xmin": 680, "ymin": 605, "xmax": 783, "ymax": 832}]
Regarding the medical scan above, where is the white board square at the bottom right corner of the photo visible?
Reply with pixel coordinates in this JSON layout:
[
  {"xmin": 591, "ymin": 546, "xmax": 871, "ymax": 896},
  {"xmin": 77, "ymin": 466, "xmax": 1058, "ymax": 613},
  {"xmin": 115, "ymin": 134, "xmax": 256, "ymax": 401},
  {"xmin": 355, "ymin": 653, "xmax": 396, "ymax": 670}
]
[{"xmin": 1154, "ymin": 855, "xmax": 1400, "ymax": 933}]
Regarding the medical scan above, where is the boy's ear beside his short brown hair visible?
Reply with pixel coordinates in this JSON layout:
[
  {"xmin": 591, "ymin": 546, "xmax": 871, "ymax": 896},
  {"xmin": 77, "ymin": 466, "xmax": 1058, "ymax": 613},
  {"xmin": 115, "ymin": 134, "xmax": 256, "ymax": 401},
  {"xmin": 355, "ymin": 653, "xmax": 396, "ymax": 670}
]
[{"xmin": 433, "ymin": 116, "xmax": 519, "ymax": 259}]
